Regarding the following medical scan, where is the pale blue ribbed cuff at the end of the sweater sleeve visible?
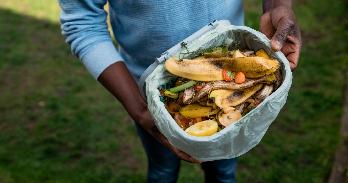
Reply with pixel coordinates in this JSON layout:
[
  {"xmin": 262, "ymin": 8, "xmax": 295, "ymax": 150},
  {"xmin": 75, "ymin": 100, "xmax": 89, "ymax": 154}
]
[{"xmin": 81, "ymin": 41, "xmax": 123, "ymax": 79}]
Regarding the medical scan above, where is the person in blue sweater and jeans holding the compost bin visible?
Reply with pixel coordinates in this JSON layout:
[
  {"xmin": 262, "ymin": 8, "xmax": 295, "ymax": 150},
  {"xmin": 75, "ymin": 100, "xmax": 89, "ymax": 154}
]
[{"xmin": 59, "ymin": 0, "xmax": 301, "ymax": 183}]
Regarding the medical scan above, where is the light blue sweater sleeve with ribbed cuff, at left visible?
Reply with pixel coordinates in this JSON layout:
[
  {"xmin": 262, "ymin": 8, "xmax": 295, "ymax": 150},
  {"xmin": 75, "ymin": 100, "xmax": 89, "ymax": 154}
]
[{"xmin": 59, "ymin": 0, "xmax": 123, "ymax": 79}]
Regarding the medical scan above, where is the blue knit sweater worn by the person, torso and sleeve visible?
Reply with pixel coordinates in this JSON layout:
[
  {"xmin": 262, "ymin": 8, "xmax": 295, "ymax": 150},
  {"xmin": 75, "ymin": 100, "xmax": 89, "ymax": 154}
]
[{"xmin": 59, "ymin": 0, "xmax": 244, "ymax": 78}]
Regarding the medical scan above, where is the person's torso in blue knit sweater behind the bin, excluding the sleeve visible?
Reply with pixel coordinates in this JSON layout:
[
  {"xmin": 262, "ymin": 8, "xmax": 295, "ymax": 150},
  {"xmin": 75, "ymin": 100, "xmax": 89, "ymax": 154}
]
[{"xmin": 109, "ymin": 0, "xmax": 244, "ymax": 77}]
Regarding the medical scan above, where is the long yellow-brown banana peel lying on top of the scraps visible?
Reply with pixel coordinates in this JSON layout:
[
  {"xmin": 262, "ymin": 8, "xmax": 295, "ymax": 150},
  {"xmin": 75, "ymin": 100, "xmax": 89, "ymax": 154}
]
[{"xmin": 165, "ymin": 56, "xmax": 280, "ymax": 81}]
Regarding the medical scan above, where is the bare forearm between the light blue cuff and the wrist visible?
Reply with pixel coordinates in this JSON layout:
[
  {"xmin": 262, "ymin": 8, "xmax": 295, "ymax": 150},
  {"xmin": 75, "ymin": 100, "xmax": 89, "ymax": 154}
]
[{"xmin": 98, "ymin": 62, "xmax": 147, "ymax": 120}]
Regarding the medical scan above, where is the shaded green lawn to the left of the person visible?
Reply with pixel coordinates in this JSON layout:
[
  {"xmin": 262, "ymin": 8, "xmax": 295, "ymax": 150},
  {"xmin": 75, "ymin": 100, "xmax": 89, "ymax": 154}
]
[{"xmin": 0, "ymin": 9, "xmax": 150, "ymax": 183}]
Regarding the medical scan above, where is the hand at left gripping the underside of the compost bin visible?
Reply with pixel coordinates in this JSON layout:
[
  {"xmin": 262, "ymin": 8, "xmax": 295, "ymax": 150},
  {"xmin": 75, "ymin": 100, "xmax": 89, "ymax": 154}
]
[{"xmin": 136, "ymin": 108, "xmax": 200, "ymax": 163}]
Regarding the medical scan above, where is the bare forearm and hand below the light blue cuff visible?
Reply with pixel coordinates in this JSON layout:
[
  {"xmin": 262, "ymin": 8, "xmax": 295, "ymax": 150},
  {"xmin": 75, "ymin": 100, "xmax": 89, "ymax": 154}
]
[{"xmin": 98, "ymin": 62, "xmax": 198, "ymax": 163}]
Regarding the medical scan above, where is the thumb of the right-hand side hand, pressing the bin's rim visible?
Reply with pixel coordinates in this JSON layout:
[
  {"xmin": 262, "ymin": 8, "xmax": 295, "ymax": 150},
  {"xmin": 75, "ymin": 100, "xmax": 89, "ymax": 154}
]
[{"xmin": 271, "ymin": 17, "xmax": 295, "ymax": 51}]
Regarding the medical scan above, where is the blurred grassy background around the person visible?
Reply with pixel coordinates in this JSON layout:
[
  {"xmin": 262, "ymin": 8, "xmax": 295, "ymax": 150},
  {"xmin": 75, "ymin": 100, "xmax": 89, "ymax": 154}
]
[{"xmin": 0, "ymin": 0, "xmax": 348, "ymax": 183}]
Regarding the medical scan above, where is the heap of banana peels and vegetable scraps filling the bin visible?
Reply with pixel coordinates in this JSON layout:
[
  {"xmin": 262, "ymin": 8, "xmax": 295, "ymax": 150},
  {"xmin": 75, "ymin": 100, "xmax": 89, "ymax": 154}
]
[{"xmin": 160, "ymin": 47, "xmax": 282, "ymax": 136}]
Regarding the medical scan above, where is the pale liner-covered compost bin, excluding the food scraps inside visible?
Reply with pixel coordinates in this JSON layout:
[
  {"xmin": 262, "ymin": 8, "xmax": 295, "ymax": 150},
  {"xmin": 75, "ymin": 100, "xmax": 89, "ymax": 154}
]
[{"xmin": 139, "ymin": 20, "xmax": 292, "ymax": 162}]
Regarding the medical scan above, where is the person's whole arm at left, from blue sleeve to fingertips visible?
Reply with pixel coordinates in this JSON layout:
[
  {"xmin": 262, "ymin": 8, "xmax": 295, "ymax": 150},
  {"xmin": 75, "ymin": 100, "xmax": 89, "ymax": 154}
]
[{"xmin": 59, "ymin": 0, "xmax": 196, "ymax": 162}]
